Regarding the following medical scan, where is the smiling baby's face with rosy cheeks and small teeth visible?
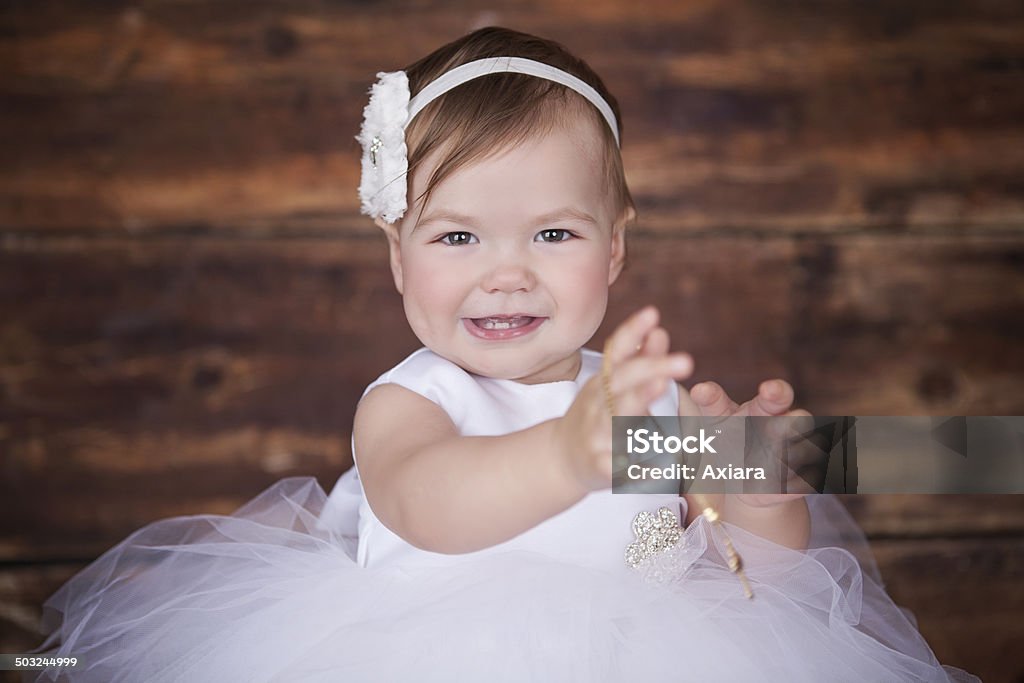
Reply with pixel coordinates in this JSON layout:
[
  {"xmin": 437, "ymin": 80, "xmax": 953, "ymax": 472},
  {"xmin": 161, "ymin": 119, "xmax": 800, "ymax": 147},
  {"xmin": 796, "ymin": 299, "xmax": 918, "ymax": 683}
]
[{"xmin": 388, "ymin": 117, "xmax": 624, "ymax": 384}]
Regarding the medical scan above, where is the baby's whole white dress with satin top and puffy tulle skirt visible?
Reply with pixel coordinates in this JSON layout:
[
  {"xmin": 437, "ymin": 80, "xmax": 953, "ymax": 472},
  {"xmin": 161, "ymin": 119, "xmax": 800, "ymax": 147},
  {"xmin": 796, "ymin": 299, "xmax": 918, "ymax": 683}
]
[{"xmin": 29, "ymin": 349, "xmax": 978, "ymax": 683}]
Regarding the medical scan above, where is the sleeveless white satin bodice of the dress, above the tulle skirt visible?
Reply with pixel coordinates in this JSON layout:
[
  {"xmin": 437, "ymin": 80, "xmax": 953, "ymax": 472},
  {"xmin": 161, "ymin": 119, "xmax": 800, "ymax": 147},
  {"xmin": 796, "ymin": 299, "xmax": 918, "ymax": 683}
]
[{"xmin": 324, "ymin": 348, "xmax": 685, "ymax": 570}]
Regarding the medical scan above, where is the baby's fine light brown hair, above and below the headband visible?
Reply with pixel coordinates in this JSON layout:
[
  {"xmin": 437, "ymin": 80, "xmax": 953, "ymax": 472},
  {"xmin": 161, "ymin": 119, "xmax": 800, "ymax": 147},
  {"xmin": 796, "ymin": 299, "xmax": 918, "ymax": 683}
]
[{"xmin": 404, "ymin": 27, "xmax": 636, "ymax": 232}]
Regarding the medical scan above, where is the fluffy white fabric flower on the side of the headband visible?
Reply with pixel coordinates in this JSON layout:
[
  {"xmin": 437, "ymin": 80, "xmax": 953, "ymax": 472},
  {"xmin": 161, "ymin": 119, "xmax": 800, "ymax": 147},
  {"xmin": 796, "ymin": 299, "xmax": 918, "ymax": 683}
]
[{"xmin": 355, "ymin": 71, "xmax": 409, "ymax": 223}]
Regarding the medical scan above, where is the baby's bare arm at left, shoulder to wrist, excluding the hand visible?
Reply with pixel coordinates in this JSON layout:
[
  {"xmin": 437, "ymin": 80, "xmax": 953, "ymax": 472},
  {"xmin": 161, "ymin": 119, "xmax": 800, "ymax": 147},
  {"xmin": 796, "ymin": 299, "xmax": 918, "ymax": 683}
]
[{"xmin": 354, "ymin": 384, "xmax": 588, "ymax": 553}]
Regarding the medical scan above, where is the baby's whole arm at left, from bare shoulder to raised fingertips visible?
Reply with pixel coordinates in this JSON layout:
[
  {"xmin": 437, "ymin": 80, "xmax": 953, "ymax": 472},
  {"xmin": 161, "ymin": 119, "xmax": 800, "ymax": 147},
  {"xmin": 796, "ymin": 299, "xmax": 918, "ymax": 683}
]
[{"xmin": 353, "ymin": 308, "xmax": 692, "ymax": 553}]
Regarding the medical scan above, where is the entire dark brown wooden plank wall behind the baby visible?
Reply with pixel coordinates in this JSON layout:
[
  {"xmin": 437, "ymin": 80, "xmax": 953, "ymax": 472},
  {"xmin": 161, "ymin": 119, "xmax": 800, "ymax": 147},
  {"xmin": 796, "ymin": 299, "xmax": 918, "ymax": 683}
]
[{"xmin": 0, "ymin": 0, "xmax": 1024, "ymax": 681}]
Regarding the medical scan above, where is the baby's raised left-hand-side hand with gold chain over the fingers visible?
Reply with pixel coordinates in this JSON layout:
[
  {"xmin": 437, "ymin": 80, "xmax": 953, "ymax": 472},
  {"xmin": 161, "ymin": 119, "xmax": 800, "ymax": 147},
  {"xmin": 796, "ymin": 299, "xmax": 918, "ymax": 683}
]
[{"xmin": 557, "ymin": 306, "xmax": 693, "ymax": 490}]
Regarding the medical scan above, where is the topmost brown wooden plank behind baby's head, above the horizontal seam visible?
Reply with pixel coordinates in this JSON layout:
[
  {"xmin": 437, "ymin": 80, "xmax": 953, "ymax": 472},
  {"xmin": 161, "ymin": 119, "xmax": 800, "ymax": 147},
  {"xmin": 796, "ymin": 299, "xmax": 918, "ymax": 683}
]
[{"xmin": 0, "ymin": 0, "xmax": 1024, "ymax": 233}]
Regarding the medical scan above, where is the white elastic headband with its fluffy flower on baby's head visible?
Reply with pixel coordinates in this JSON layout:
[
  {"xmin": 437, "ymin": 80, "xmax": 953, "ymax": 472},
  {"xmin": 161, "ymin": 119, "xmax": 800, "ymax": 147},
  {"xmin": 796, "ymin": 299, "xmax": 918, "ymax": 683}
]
[{"xmin": 355, "ymin": 57, "xmax": 620, "ymax": 223}]
